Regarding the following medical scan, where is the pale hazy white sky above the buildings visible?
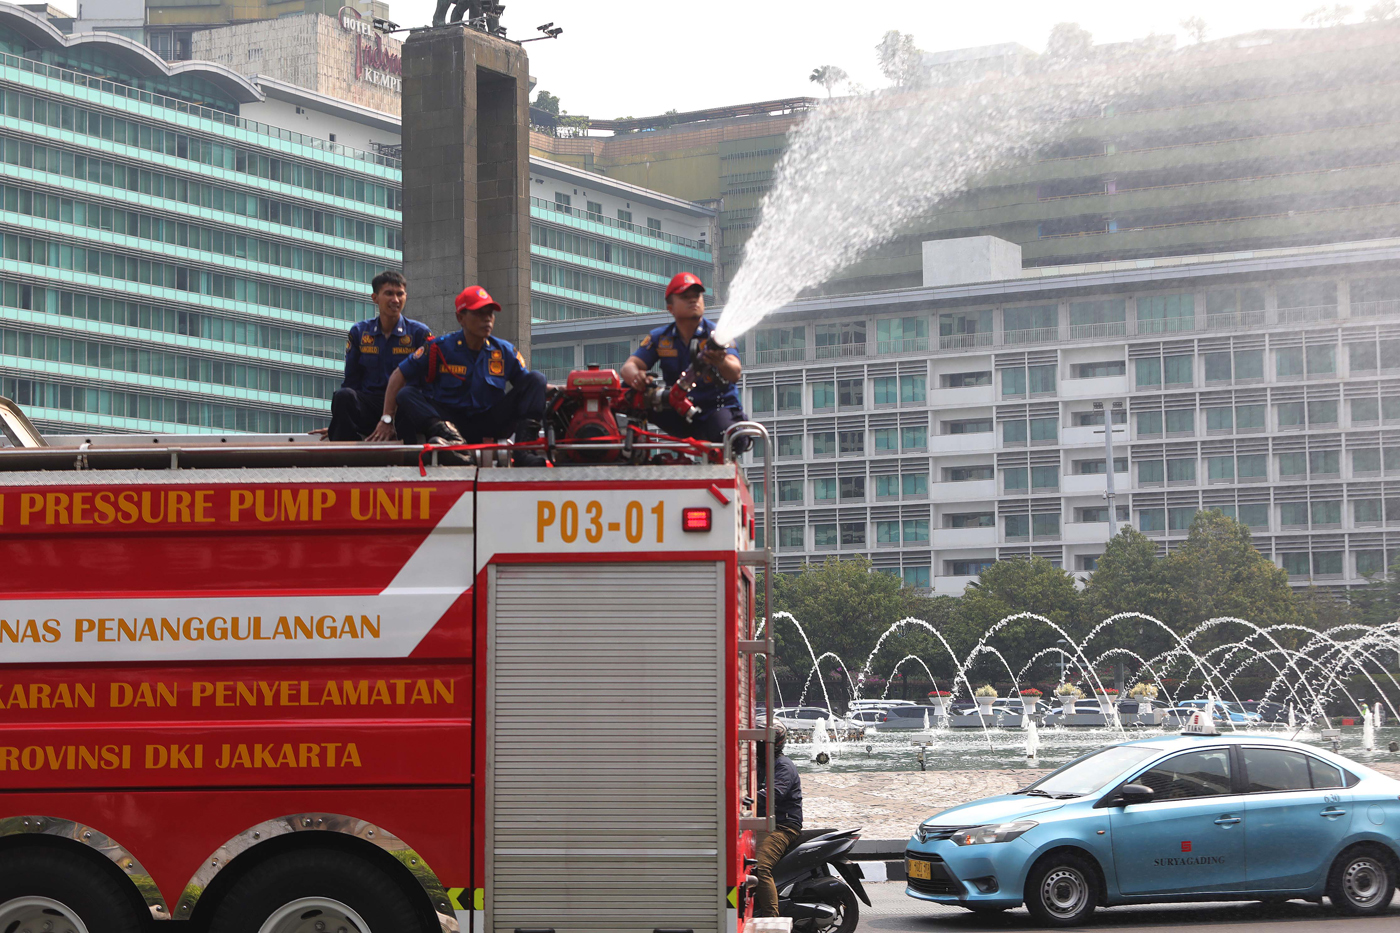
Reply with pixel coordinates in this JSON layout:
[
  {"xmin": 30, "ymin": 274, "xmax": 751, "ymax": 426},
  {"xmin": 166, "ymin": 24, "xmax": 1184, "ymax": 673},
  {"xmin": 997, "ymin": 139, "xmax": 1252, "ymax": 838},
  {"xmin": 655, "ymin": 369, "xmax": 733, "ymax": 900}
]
[{"xmin": 389, "ymin": 0, "xmax": 1375, "ymax": 119}]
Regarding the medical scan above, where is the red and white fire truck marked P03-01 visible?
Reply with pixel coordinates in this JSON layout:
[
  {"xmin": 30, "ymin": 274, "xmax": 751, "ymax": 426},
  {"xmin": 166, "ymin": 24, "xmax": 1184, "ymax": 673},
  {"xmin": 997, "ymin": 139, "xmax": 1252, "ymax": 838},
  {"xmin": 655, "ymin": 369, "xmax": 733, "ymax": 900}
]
[{"xmin": 0, "ymin": 403, "xmax": 771, "ymax": 933}]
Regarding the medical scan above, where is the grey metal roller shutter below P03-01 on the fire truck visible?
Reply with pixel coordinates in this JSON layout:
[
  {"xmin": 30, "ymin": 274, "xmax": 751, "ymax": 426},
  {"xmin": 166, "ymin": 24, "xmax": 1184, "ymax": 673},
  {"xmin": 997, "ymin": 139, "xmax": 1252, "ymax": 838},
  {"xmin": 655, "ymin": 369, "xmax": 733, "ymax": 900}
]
[{"xmin": 486, "ymin": 563, "xmax": 728, "ymax": 933}]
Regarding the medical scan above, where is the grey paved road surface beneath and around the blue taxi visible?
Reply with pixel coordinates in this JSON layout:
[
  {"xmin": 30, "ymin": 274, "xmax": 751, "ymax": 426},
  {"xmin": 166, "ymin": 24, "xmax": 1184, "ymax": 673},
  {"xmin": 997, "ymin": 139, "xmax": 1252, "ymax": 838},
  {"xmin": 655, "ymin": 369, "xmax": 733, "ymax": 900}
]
[{"xmin": 860, "ymin": 881, "xmax": 1400, "ymax": 933}]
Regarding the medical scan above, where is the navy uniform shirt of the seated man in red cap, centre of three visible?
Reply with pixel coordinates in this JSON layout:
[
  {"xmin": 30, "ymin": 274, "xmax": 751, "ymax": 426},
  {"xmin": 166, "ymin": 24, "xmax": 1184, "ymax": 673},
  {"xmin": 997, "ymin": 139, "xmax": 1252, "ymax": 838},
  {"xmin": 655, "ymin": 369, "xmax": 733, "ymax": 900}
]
[{"xmin": 399, "ymin": 331, "xmax": 528, "ymax": 412}]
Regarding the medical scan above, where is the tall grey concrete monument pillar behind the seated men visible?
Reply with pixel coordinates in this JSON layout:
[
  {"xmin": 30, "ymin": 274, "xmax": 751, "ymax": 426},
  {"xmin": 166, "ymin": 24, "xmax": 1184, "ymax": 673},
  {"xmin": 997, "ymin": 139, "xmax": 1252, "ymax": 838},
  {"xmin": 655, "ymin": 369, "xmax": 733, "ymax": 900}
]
[{"xmin": 403, "ymin": 25, "xmax": 531, "ymax": 359}]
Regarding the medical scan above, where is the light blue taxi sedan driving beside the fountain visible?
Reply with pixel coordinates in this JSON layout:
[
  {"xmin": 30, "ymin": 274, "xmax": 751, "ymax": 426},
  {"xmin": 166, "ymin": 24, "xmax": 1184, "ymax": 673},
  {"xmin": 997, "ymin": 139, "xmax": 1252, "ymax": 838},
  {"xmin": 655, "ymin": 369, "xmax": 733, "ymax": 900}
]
[{"xmin": 906, "ymin": 716, "xmax": 1400, "ymax": 926}]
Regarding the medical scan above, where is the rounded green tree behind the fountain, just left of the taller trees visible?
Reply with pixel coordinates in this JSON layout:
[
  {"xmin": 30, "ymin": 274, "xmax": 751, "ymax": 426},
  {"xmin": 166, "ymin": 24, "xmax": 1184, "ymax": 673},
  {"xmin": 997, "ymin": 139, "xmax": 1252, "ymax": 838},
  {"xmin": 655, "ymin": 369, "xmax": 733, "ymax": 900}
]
[{"xmin": 948, "ymin": 556, "xmax": 1084, "ymax": 681}]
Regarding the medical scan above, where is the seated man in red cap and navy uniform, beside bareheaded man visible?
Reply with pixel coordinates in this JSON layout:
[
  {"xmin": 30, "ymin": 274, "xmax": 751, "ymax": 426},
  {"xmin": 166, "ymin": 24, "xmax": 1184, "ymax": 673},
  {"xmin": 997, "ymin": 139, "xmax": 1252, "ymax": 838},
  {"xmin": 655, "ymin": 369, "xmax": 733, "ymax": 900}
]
[{"xmin": 384, "ymin": 286, "xmax": 546, "ymax": 467}]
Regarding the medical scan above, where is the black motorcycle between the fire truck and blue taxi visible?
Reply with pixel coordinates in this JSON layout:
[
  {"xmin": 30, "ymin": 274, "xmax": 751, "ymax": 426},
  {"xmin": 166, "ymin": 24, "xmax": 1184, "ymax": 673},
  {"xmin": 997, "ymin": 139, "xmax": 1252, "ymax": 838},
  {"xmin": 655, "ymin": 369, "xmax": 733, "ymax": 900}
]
[{"xmin": 773, "ymin": 829, "xmax": 871, "ymax": 933}]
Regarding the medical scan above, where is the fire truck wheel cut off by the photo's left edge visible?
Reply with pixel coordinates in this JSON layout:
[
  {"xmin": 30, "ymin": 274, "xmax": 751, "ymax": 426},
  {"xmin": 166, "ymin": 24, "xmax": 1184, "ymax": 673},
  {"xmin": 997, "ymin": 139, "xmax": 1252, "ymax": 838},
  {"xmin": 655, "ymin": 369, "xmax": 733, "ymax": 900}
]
[{"xmin": 0, "ymin": 848, "xmax": 144, "ymax": 933}]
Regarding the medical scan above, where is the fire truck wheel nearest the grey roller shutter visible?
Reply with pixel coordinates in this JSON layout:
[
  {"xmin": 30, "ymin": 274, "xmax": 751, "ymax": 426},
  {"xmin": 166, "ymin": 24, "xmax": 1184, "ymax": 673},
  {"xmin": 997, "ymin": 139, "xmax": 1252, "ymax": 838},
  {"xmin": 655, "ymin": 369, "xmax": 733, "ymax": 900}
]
[{"xmin": 209, "ymin": 849, "xmax": 423, "ymax": 933}]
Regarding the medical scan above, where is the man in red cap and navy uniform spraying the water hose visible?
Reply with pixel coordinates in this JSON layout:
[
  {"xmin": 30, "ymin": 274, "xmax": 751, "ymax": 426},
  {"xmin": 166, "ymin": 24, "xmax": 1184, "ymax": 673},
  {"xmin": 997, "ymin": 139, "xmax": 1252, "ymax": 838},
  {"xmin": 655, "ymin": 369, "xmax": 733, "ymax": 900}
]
[{"xmin": 622, "ymin": 272, "xmax": 748, "ymax": 451}]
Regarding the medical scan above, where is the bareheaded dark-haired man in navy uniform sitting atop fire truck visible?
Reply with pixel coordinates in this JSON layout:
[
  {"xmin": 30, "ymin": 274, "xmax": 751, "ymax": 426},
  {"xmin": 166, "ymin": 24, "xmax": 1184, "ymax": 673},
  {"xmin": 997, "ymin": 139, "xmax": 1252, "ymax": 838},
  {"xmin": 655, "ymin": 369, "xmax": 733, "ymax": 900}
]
[{"xmin": 328, "ymin": 270, "xmax": 433, "ymax": 441}]
